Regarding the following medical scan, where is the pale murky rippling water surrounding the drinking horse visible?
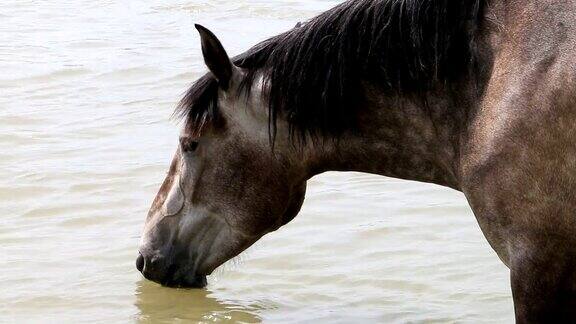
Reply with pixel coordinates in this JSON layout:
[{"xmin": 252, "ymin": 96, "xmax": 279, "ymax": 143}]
[{"xmin": 0, "ymin": 0, "xmax": 513, "ymax": 323}]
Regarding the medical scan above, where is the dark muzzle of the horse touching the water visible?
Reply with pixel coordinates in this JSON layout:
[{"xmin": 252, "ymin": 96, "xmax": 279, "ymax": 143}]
[{"xmin": 136, "ymin": 253, "xmax": 207, "ymax": 288}]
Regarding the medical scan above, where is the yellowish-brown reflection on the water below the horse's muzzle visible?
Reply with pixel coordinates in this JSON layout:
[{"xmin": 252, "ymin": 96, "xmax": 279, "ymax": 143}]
[{"xmin": 135, "ymin": 279, "xmax": 261, "ymax": 323}]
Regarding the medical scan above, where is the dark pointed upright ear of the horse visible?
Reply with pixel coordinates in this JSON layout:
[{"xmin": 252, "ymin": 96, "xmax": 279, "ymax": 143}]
[{"xmin": 195, "ymin": 24, "xmax": 234, "ymax": 90}]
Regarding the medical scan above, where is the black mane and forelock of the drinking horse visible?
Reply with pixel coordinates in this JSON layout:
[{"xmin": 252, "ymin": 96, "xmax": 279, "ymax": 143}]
[{"xmin": 178, "ymin": 0, "xmax": 484, "ymax": 137}]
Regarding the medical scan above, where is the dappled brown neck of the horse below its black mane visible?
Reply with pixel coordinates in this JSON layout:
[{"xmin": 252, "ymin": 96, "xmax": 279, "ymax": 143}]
[{"xmin": 310, "ymin": 86, "xmax": 467, "ymax": 189}]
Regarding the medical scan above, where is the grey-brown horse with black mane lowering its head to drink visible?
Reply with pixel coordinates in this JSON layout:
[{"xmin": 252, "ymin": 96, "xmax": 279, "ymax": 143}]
[{"xmin": 136, "ymin": 0, "xmax": 576, "ymax": 323}]
